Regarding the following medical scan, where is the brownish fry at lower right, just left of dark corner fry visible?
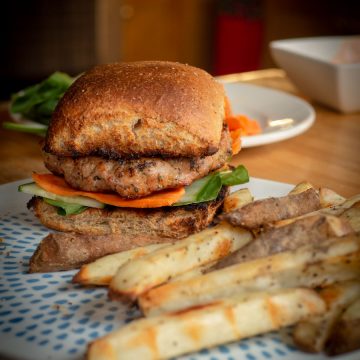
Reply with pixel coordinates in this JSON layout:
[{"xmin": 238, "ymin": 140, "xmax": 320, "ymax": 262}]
[{"xmin": 293, "ymin": 280, "xmax": 360, "ymax": 352}]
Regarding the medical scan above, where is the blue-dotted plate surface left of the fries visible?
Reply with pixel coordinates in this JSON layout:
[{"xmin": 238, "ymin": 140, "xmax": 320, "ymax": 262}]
[{"xmin": 0, "ymin": 212, "xmax": 140, "ymax": 360}]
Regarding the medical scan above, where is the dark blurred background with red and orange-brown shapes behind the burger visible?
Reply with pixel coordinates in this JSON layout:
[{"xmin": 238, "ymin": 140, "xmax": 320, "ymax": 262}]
[{"xmin": 0, "ymin": 0, "xmax": 360, "ymax": 100}]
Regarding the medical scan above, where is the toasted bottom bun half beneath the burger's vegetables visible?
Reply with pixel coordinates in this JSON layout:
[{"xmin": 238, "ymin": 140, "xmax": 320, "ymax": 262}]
[{"xmin": 28, "ymin": 187, "xmax": 228, "ymax": 239}]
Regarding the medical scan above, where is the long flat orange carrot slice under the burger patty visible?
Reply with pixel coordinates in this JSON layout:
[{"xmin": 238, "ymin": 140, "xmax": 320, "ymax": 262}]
[{"xmin": 32, "ymin": 173, "xmax": 185, "ymax": 208}]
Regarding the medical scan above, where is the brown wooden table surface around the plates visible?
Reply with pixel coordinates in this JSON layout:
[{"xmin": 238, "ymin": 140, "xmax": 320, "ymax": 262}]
[{"xmin": 0, "ymin": 69, "xmax": 360, "ymax": 196}]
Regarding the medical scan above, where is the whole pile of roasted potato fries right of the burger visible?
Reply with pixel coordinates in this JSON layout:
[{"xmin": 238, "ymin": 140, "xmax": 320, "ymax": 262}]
[{"xmin": 73, "ymin": 183, "xmax": 360, "ymax": 360}]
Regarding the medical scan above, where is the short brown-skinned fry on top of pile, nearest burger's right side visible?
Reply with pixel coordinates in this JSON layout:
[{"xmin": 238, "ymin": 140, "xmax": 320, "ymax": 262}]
[{"xmin": 223, "ymin": 188, "xmax": 320, "ymax": 229}]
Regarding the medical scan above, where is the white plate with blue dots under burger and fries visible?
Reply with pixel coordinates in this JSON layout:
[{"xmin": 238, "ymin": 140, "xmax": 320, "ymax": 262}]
[{"xmin": 0, "ymin": 178, "xmax": 360, "ymax": 360}]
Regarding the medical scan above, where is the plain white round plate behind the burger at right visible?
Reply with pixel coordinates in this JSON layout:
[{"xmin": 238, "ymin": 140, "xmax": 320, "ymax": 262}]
[{"xmin": 224, "ymin": 82, "xmax": 315, "ymax": 148}]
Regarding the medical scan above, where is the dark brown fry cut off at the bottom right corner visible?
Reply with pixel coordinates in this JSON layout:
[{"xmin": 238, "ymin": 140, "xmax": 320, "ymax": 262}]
[{"xmin": 325, "ymin": 298, "xmax": 360, "ymax": 356}]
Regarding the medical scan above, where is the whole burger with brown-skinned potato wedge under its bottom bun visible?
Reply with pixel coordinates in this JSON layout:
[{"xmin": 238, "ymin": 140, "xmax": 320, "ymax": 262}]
[{"xmin": 19, "ymin": 61, "xmax": 247, "ymax": 271}]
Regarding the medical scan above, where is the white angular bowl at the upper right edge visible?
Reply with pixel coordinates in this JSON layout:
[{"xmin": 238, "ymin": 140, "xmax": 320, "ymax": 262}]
[{"xmin": 270, "ymin": 36, "xmax": 360, "ymax": 112}]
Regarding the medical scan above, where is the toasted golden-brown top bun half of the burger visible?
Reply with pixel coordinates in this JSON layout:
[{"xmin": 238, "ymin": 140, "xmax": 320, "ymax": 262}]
[{"xmin": 45, "ymin": 61, "xmax": 225, "ymax": 159}]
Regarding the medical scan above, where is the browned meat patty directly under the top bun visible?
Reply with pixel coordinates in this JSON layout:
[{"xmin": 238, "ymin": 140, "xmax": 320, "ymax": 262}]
[{"xmin": 44, "ymin": 129, "xmax": 231, "ymax": 198}]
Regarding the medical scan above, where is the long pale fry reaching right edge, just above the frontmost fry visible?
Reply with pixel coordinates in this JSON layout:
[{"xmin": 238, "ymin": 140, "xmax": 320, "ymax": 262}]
[{"xmin": 139, "ymin": 234, "xmax": 360, "ymax": 316}]
